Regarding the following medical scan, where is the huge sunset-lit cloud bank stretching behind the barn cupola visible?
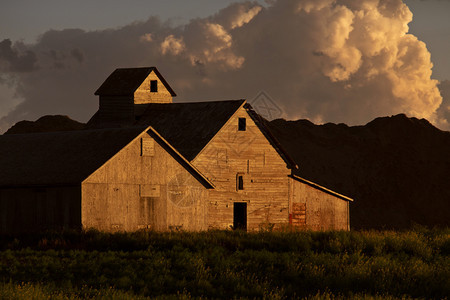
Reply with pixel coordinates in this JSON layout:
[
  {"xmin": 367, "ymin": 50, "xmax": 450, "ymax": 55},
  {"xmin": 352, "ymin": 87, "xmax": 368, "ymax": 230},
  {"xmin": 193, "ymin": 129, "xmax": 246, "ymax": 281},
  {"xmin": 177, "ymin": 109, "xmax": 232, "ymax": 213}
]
[{"xmin": 0, "ymin": 0, "xmax": 450, "ymax": 129}]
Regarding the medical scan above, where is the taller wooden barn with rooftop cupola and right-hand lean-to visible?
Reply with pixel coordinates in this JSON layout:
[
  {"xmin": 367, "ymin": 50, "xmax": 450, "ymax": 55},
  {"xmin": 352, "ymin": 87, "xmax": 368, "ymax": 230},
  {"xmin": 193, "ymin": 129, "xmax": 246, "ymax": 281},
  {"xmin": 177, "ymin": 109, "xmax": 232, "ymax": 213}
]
[{"xmin": 88, "ymin": 67, "xmax": 352, "ymax": 230}]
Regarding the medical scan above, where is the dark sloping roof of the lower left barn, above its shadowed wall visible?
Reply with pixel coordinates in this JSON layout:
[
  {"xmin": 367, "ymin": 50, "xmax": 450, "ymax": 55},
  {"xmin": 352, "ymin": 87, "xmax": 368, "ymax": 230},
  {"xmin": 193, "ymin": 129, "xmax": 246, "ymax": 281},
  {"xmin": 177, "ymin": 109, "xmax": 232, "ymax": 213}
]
[{"xmin": 0, "ymin": 127, "xmax": 145, "ymax": 186}]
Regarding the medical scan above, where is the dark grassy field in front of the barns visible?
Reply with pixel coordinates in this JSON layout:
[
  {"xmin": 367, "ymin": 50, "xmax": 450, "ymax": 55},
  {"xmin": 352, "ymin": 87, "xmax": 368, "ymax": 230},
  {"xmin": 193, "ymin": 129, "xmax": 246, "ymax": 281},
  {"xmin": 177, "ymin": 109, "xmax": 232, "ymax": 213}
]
[{"xmin": 0, "ymin": 229, "xmax": 450, "ymax": 299}]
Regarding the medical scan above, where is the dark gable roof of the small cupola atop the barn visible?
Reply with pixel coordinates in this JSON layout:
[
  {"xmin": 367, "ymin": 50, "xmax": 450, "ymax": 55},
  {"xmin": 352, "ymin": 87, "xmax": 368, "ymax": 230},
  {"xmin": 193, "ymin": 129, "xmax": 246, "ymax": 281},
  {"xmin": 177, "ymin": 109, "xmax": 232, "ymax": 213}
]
[{"xmin": 95, "ymin": 67, "xmax": 176, "ymax": 97}]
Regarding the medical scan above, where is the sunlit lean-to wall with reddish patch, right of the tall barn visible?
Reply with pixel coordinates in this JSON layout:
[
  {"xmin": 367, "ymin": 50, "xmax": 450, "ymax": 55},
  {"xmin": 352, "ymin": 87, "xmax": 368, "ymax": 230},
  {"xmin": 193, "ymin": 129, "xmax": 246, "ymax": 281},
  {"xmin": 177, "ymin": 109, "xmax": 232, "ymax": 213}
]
[{"xmin": 289, "ymin": 179, "xmax": 350, "ymax": 230}]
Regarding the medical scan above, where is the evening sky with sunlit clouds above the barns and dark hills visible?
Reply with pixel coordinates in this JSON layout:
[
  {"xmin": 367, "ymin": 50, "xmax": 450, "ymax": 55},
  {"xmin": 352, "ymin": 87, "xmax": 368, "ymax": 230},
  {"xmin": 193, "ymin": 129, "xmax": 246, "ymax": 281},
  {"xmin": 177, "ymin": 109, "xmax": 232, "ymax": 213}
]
[{"xmin": 0, "ymin": 0, "xmax": 450, "ymax": 133}]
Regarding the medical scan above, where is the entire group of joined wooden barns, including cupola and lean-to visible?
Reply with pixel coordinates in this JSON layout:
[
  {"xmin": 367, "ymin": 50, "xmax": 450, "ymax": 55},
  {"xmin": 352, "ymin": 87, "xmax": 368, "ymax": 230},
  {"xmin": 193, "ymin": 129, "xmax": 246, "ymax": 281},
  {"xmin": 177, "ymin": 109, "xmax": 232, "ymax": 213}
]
[{"xmin": 0, "ymin": 67, "xmax": 352, "ymax": 232}]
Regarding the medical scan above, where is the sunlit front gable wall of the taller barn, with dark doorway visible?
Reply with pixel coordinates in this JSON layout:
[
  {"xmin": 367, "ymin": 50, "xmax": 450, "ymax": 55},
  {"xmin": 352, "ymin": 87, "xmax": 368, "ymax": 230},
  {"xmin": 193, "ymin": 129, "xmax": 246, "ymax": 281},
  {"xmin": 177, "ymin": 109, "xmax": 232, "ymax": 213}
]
[{"xmin": 192, "ymin": 108, "xmax": 290, "ymax": 230}]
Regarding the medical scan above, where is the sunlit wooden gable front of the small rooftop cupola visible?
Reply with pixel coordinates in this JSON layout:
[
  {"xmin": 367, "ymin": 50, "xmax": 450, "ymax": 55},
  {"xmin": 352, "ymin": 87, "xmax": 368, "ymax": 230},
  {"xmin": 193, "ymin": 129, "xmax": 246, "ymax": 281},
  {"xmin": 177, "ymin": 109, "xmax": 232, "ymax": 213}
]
[{"xmin": 134, "ymin": 72, "xmax": 172, "ymax": 104}]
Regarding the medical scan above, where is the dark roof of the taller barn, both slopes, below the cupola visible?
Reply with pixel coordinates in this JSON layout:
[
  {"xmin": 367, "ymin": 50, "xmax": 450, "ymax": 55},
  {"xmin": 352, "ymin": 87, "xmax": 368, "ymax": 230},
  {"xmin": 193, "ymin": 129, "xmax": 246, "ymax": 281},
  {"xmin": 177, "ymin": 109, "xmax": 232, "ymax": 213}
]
[{"xmin": 87, "ymin": 99, "xmax": 298, "ymax": 169}]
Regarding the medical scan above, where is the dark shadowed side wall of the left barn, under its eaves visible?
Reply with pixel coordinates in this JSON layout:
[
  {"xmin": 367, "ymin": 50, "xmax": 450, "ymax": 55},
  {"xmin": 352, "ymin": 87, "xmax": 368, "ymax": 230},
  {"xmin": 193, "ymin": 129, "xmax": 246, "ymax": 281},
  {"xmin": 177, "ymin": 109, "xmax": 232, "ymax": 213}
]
[{"xmin": 0, "ymin": 186, "xmax": 81, "ymax": 234}]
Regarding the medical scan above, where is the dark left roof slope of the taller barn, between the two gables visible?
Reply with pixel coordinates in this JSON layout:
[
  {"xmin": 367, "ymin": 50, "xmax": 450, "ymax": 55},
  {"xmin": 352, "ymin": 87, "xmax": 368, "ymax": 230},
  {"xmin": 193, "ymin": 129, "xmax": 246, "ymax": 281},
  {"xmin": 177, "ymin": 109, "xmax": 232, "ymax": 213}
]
[{"xmin": 136, "ymin": 99, "xmax": 245, "ymax": 161}]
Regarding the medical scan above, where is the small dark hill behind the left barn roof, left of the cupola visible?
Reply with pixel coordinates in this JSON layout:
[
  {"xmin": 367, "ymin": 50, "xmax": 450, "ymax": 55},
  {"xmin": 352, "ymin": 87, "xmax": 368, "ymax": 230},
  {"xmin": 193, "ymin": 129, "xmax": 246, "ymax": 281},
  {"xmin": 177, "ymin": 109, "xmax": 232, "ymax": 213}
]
[{"xmin": 5, "ymin": 115, "xmax": 85, "ymax": 134}]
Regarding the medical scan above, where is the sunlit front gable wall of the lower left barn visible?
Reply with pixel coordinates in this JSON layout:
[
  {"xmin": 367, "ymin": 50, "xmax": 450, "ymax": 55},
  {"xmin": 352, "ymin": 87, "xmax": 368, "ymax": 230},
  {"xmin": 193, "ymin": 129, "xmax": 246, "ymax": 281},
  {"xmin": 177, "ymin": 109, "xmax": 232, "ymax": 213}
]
[{"xmin": 82, "ymin": 133, "xmax": 208, "ymax": 231}]
